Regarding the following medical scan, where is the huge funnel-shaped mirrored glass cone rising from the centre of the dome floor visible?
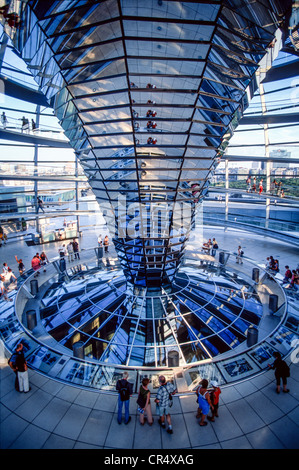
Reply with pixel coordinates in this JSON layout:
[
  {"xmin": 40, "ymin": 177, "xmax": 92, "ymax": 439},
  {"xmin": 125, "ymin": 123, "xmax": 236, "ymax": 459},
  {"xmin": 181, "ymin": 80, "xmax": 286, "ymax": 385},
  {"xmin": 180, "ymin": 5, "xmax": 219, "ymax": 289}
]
[{"xmin": 1, "ymin": 0, "xmax": 288, "ymax": 288}]
